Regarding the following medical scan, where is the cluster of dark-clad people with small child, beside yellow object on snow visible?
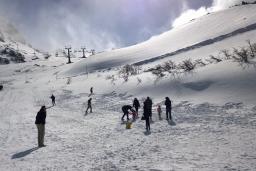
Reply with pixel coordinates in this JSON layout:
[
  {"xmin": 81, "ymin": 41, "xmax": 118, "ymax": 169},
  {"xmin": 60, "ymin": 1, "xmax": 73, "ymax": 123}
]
[{"xmin": 121, "ymin": 97, "xmax": 172, "ymax": 131}]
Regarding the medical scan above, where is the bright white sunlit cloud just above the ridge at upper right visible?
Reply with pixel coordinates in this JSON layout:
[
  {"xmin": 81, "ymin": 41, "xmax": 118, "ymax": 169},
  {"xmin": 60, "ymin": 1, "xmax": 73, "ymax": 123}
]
[{"xmin": 172, "ymin": 0, "xmax": 255, "ymax": 28}]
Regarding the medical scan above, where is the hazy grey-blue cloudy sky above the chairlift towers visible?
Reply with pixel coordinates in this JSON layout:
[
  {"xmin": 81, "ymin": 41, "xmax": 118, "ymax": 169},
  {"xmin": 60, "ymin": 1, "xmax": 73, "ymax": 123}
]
[{"xmin": 0, "ymin": 0, "xmax": 213, "ymax": 51}]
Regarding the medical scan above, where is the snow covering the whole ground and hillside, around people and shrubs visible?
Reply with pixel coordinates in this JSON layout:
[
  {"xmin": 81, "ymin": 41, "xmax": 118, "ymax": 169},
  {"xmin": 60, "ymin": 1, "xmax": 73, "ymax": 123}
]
[{"xmin": 0, "ymin": 5, "xmax": 256, "ymax": 171}]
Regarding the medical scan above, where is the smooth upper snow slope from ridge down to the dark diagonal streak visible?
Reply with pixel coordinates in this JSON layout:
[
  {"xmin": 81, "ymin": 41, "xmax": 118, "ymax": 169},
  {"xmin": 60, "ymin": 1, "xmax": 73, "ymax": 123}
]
[{"xmin": 66, "ymin": 5, "xmax": 256, "ymax": 75}]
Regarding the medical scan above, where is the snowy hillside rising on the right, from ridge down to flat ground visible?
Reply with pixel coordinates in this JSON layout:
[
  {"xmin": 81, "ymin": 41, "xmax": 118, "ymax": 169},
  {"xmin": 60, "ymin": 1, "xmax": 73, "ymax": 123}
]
[{"xmin": 60, "ymin": 5, "xmax": 256, "ymax": 104}]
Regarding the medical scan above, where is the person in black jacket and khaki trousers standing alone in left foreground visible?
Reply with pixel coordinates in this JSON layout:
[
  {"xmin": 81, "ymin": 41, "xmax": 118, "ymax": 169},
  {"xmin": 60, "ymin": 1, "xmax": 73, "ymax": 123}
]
[{"xmin": 35, "ymin": 106, "xmax": 46, "ymax": 147}]
